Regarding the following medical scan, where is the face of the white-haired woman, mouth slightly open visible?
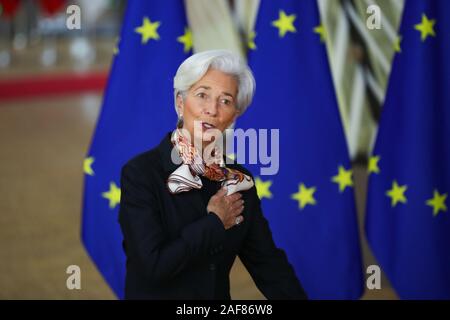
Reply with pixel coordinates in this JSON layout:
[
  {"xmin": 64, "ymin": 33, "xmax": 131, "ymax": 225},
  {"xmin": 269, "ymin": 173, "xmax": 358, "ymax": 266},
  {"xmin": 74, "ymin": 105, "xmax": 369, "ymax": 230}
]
[{"xmin": 177, "ymin": 69, "xmax": 239, "ymax": 147}]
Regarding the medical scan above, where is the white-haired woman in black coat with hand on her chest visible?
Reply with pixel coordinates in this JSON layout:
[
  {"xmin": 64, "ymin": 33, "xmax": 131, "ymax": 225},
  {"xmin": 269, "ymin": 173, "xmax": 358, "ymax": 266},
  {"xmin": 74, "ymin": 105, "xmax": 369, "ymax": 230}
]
[{"xmin": 119, "ymin": 50, "xmax": 306, "ymax": 299}]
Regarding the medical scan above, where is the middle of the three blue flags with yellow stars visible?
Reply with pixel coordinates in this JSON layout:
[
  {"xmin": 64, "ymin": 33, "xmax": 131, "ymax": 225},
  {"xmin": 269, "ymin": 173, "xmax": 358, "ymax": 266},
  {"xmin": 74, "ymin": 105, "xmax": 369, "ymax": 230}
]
[{"xmin": 237, "ymin": 0, "xmax": 363, "ymax": 299}]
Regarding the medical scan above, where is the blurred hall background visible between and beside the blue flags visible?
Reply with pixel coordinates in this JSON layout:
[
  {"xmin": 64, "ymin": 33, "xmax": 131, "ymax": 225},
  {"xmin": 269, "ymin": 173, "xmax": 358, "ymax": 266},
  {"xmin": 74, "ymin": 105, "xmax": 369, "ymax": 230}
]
[{"xmin": 0, "ymin": 0, "xmax": 403, "ymax": 299}]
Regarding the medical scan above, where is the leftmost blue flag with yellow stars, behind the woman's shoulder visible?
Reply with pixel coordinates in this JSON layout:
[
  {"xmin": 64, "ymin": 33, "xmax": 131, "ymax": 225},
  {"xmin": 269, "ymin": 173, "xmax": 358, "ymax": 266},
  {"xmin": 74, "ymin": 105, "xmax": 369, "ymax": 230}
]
[{"xmin": 82, "ymin": 0, "xmax": 192, "ymax": 298}]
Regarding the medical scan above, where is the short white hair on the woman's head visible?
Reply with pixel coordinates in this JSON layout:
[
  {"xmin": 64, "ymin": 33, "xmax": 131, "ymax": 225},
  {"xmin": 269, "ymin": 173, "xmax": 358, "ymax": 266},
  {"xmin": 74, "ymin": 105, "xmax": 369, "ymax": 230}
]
[{"xmin": 173, "ymin": 50, "xmax": 256, "ymax": 114}]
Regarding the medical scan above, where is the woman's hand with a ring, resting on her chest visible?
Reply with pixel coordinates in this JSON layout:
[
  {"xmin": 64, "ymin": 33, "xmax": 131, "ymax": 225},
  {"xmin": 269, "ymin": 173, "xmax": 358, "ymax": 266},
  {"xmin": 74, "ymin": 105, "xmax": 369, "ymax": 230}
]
[{"xmin": 206, "ymin": 188, "xmax": 244, "ymax": 230}]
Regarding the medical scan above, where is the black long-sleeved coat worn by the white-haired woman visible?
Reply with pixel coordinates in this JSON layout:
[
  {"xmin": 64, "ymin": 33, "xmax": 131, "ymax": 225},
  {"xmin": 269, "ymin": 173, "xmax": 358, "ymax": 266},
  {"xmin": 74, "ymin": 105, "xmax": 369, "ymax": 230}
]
[{"xmin": 119, "ymin": 133, "xmax": 306, "ymax": 299}]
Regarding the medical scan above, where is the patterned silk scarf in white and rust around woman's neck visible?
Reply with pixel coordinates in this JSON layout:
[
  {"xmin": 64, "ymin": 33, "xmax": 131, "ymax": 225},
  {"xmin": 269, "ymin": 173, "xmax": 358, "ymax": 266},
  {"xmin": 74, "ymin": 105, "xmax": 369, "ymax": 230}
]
[{"xmin": 167, "ymin": 129, "xmax": 254, "ymax": 195}]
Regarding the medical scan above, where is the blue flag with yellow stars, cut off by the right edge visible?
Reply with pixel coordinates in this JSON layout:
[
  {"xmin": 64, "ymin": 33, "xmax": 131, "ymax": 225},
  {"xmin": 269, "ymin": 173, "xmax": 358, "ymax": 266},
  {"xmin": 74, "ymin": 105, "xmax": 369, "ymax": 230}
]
[{"xmin": 366, "ymin": 0, "xmax": 450, "ymax": 299}]
